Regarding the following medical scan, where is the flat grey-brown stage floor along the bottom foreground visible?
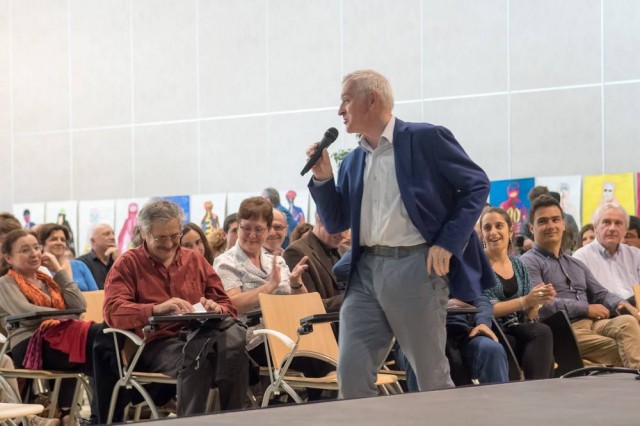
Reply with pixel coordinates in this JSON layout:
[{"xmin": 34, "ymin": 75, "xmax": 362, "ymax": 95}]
[{"xmin": 145, "ymin": 374, "xmax": 640, "ymax": 426}]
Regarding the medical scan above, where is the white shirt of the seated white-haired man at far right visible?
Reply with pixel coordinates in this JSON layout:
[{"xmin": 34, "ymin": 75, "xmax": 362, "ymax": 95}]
[{"xmin": 573, "ymin": 239, "xmax": 640, "ymax": 299}]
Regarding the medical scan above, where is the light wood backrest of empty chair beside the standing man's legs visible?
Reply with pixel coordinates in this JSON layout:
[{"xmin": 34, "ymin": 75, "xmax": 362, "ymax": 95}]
[{"xmin": 259, "ymin": 292, "xmax": 338, "ymax": 368}]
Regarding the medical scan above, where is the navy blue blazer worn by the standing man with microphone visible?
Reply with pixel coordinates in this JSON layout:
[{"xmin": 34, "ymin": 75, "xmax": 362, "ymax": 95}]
[{"xmin": 309, "ymin": 119, "xmax": 495, "ymax": 300}]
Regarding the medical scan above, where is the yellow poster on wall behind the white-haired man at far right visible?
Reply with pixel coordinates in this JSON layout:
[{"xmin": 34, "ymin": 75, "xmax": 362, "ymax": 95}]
[{"xmin": 582, "ymin": 173, "xmax": 636, "ymax": 224}]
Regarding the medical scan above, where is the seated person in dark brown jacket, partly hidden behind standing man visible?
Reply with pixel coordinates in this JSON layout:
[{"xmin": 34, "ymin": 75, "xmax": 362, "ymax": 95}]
[{"xmin": 283, "ymin": 214, "xmax": 344, "ymax": 312}]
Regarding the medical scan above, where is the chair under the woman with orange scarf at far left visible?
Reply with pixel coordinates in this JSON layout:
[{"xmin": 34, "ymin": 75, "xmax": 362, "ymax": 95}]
[{"xmin": 0, "ymin": 309, "xmax": 91, "ymax": 424}]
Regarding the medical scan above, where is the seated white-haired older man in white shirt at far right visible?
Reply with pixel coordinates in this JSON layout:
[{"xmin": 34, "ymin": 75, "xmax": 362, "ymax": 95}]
[{"xmin": 573, "ymin": 203, "xmax": 640, "ymax": 304}]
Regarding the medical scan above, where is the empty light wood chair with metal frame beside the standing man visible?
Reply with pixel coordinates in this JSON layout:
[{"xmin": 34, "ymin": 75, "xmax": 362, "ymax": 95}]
[{"xmin": 254, "ymin": 293, "xmax": 399, "ymax": 407}]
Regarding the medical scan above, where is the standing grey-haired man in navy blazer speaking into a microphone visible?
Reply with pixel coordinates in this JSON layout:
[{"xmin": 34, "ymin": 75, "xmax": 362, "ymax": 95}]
[{"xmin": 307, "ymin": 70, "xmax": 494, "ymax": 398}]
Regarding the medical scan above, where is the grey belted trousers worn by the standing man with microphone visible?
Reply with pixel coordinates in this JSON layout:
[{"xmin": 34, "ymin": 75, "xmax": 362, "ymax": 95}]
[{"xmin": 338, "ymin": 248, "xmax": 453, "ymax": 398}]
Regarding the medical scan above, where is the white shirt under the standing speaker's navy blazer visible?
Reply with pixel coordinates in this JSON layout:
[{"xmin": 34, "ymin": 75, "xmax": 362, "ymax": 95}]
[{"xmin": 358, "ymin": 117, "xmax": 425, "ymax": 247}]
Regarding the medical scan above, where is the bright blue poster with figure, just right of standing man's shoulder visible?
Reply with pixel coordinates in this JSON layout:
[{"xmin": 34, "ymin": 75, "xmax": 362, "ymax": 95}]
[{"xmin": 489, "ymin": 178, "xmax": 534, "ymax": 234}]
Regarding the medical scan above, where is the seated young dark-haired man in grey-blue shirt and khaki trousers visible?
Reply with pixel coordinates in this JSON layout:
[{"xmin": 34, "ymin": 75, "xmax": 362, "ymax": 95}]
[{"xmin": 520, "ymin": 196, "xmax": 640, "ymax": 368}]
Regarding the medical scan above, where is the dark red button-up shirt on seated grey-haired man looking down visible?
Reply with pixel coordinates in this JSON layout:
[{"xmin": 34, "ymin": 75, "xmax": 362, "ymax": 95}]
[{"xmin": 103, "ymin": 245, "xmax": 237, "ymax": 341}]
